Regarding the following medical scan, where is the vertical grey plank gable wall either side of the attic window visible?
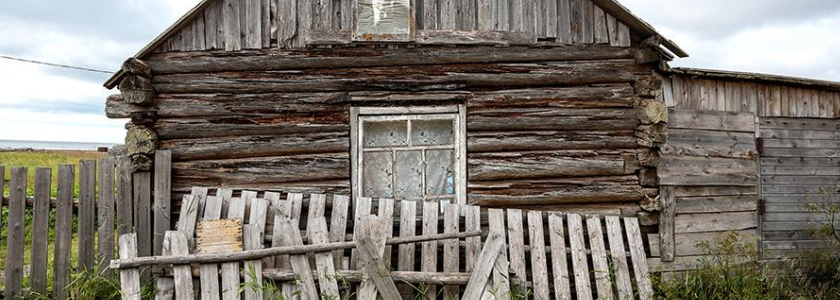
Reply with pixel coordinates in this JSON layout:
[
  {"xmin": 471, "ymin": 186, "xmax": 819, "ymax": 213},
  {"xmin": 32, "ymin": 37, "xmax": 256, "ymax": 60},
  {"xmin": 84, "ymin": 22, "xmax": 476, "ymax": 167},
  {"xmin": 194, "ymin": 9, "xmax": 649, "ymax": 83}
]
[{"xmin": 157, "ymin": 0, "xmax": 631, "ymax": 52}]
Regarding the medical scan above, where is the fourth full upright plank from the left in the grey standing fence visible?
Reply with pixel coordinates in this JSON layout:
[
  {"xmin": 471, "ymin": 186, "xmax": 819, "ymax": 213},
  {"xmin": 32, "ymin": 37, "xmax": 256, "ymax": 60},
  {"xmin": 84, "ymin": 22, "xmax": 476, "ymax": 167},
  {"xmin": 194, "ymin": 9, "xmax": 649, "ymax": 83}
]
[{"xmin": 76, "ymin": 160, "xmax": 97, "ymax": 270}]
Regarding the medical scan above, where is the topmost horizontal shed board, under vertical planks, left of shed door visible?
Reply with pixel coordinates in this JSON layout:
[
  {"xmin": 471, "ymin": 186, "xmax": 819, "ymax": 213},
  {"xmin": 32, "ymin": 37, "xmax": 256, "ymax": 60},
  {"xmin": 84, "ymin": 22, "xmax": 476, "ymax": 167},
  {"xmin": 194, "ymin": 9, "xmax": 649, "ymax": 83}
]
[{"xmin": 668, "ymin": 109, "xmax": 755, "ymax": 132}]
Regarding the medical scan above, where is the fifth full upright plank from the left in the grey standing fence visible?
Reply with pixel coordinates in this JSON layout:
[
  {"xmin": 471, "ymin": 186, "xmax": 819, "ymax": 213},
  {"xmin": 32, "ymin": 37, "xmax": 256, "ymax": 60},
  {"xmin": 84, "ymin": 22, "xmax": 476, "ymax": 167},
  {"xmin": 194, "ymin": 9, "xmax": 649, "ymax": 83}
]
[{"xmin": 96, "ymin": 158, "xmax": 114, "ymax": 275}]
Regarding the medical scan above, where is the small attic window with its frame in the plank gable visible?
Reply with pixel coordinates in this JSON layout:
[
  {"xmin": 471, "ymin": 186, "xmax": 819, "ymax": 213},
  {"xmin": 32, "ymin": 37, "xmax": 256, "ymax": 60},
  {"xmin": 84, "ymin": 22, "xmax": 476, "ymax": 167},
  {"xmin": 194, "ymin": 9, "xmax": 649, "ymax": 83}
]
[{"xmin": 354, "ymin": 0, "xmax": 414, "ymax": 41}]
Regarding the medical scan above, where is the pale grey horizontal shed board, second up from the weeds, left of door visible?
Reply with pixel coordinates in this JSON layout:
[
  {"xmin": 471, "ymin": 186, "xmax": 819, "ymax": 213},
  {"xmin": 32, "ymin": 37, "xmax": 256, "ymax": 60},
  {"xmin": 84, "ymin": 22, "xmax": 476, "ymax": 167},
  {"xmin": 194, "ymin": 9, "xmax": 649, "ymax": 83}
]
[{"xmin": 674, "ymin": 212, "xmax": 758, "ymax": 233}]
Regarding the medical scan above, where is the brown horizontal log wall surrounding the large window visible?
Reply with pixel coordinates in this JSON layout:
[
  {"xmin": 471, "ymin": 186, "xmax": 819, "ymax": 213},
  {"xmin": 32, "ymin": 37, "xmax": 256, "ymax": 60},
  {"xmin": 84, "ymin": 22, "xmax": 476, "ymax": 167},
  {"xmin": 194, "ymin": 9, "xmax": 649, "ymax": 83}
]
[{"xmin": 108, "ymin": 46, "xmax": 658, "ymax": 215}]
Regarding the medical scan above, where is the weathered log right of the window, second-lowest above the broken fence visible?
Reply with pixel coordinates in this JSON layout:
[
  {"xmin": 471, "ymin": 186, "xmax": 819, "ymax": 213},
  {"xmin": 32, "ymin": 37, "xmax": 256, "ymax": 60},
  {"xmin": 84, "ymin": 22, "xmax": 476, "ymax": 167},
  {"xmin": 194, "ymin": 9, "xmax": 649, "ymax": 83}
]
[{"xmin": 467, "ymin": 150, "xmax": 638, "ymax": 183}]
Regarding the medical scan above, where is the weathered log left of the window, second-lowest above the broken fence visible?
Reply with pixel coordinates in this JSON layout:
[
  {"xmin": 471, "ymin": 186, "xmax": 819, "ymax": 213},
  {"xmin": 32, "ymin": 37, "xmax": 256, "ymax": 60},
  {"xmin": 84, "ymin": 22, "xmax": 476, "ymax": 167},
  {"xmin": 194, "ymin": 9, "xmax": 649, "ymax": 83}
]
[{"xmin": 172, "ymin": 152, "xmax": 350, "ymax": 185}]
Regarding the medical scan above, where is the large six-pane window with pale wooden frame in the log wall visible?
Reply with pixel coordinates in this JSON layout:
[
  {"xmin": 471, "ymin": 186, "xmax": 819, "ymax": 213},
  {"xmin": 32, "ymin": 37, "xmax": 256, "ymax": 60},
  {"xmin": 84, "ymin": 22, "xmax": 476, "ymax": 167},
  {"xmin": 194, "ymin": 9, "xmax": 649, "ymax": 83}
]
[{"xmin": 351, "ymin": 105, "xmax": 466, "ymax": 204}]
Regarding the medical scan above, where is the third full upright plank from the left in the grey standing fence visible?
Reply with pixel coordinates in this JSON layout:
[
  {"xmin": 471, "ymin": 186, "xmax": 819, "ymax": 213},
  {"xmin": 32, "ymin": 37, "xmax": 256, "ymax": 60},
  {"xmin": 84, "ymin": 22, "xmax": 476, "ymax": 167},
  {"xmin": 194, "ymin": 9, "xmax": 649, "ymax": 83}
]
[{"xmin": 53, "ymin": 165, "xmax": 74, "ymax": 300}]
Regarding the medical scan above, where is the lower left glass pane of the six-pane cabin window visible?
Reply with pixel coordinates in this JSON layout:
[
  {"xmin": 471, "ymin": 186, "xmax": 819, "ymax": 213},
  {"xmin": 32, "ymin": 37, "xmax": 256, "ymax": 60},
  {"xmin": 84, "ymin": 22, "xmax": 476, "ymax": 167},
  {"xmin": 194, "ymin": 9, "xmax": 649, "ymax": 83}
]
[{"xmin": 362, "ymin": 152, "xmax": 393, "ymax": 198}]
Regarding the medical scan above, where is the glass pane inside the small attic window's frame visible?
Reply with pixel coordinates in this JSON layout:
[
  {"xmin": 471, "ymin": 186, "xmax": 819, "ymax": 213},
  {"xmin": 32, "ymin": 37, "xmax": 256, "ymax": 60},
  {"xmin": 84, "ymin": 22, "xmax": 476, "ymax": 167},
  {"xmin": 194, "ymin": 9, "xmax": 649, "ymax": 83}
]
[{"xmin": 357, "ymin": 0, "xmax": 411, "ymax": 35}]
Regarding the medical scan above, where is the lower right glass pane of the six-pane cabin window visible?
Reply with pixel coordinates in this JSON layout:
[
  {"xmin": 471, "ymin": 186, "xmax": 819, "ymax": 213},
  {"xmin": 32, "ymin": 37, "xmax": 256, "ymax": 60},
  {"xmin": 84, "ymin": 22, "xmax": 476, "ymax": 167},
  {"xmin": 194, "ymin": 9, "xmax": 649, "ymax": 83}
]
[{"xmin": 426, "ymin": 150, "xmax": 455, "ymax": 195}]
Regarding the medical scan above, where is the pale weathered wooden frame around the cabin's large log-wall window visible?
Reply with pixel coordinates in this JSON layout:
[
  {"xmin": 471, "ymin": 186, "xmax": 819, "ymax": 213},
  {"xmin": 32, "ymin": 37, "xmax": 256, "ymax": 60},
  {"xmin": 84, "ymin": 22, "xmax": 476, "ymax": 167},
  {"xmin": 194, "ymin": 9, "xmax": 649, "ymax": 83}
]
[{"xmin": 350, "ymin": 104, "xmax": 467, "ymax": 206}]
